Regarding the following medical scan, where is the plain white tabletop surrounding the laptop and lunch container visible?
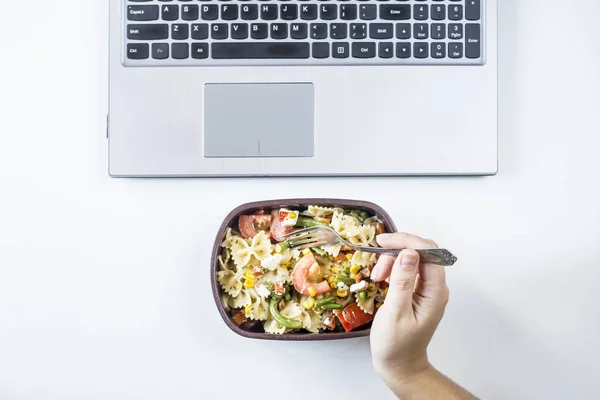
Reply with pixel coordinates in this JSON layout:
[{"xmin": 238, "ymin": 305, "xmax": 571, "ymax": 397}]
[{"xmin": 0, "ymin": 0, "xmax": 600, "ymax": 400}]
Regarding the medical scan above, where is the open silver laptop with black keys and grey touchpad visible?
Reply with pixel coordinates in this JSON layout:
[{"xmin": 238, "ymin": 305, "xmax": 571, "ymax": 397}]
[{"xmin": 107, "ymin": 0, "xmax": 498, "ymax": 177}]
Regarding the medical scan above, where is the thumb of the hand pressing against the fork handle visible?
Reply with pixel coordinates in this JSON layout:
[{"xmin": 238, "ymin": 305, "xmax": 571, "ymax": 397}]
[{"xmin": 385, "ymin": 249, "xmax": 419, "ymax": 315}]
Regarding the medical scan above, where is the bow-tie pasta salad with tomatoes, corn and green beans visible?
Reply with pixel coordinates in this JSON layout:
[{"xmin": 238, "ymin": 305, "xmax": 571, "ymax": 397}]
[{"xmin": 217, "ymin": 205, "xmax": 387, "ymax": 334}]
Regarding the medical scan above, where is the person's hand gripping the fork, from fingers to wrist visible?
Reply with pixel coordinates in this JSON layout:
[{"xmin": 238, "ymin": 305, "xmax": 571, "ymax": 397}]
[{"xmin": 370, "ymin": 233, "xmax": 449, "ymax": 383}]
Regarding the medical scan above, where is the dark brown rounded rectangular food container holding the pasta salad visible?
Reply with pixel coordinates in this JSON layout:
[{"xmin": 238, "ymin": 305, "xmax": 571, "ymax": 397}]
[{"xmin": 210, "ymin": 198, "xmax": 396, "ymax": 341}]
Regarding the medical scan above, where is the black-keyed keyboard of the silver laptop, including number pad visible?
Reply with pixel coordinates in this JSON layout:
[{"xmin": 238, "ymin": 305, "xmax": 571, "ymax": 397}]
[{"xmin": 123, "ymin": 0, "xmax": 485, "ymax": 67}]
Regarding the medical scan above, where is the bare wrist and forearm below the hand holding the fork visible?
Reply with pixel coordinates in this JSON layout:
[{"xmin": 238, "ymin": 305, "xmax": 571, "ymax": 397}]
[{"xmin": 385, "ymin": 366, "xmax": 477, "ymax": 400}]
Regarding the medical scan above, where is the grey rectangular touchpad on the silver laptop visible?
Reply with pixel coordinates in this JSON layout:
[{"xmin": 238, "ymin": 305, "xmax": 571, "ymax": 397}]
[{"xmin": 204, "ymin": 83, "xmax": 315, "ymax": 158}]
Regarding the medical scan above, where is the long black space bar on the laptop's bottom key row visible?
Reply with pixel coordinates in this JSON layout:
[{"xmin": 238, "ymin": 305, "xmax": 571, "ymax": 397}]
[{"xmin": 212, "ymin": 42, "xmax": 310, "ymax": 59}]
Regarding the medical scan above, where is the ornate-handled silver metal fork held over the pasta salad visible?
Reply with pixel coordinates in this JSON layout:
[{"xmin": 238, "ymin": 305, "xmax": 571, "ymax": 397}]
[{"xmin": 283, "ymin": 226, "xmax": 457, "ymax": 266}]
